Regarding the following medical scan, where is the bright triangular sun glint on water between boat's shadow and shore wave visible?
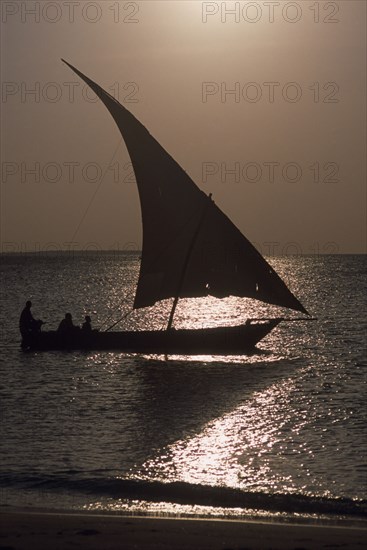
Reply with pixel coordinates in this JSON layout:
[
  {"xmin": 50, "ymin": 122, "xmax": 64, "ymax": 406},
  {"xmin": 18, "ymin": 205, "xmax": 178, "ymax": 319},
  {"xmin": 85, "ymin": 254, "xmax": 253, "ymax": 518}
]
[{"xmin": 135, "ymin": 378, "xmax": 329, "ymax": 496}]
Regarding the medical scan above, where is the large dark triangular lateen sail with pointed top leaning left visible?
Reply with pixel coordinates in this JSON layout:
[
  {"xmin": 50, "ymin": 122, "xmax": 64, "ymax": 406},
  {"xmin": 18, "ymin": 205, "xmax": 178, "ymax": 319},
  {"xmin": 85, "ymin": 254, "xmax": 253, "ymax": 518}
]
[{"xmin": 64, "ymin": 61, "xmax": 307, "ymax": 313}]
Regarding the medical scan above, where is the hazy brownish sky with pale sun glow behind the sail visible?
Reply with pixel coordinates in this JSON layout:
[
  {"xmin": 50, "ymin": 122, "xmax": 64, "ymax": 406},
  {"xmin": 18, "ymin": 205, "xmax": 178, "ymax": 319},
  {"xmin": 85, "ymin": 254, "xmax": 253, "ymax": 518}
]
[{"xmin": 1, "ymin": 0, "xmax": 366, "ymax": 254}]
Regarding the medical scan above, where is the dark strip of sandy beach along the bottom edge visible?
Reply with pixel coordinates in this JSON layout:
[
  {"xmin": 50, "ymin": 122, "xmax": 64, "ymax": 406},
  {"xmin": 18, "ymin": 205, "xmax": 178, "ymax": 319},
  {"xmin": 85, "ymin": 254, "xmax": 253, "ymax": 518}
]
[{"xmin": 0, "ymin": 511, "xmax": 367, "ymax": 550}]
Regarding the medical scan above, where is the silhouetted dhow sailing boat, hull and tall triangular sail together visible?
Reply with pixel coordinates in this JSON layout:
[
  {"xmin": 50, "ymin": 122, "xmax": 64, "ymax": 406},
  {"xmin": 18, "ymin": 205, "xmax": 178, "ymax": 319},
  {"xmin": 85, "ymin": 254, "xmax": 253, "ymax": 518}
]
[{"xmin": 23, "ymin": 60, "xmax": 310, "ymax": 355}]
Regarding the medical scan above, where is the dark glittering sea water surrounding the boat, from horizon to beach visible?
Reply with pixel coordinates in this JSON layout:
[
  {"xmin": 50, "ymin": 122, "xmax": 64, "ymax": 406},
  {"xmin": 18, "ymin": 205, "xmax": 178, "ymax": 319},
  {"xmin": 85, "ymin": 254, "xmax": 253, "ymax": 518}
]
[{"xmin": 0, "ymin": 252, "xmax": 367, "ymax": 519}]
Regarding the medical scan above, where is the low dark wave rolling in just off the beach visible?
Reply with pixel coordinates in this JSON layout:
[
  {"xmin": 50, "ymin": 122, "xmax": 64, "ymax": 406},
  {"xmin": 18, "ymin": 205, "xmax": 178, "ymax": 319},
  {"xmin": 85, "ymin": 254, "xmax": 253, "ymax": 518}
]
[{"xmin": 0, "ymin": 472, "xmax": 367, "ymax": 518}]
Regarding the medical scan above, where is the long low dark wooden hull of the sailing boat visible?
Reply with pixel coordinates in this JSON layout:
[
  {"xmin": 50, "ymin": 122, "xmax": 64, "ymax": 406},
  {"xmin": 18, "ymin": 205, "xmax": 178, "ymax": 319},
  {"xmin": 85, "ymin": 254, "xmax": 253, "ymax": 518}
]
[{"xmin": 22, "ymin": 319, "xmax": 282, "ymax": 355}]
